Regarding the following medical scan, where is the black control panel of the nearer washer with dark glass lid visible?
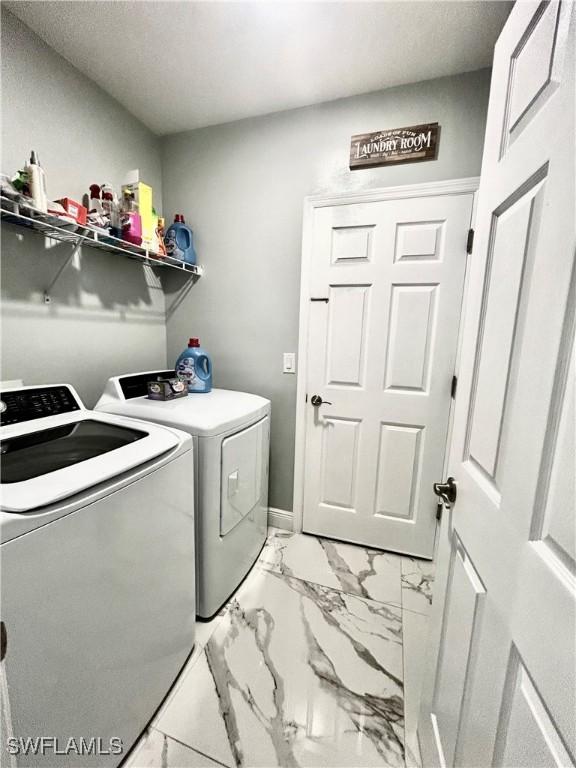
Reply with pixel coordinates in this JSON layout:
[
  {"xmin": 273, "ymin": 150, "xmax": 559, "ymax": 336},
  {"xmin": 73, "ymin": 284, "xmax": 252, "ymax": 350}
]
[{"xmin": 0, "ymin": 386, "xmax": 81, "ymax": 426}]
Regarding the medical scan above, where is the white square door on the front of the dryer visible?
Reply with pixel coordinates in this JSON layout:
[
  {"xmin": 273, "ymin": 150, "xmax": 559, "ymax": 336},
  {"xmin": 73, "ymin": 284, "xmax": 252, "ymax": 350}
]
[{"xmin": 220, "ymin": 416, "xmax": 269, "ymax": 536}]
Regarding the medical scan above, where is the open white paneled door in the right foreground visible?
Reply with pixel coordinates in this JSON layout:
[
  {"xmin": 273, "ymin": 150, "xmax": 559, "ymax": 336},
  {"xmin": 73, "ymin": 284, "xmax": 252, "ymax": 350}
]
[{"xmin": 419, "ymin": 2, "xmax": 576, "ymax": 768}]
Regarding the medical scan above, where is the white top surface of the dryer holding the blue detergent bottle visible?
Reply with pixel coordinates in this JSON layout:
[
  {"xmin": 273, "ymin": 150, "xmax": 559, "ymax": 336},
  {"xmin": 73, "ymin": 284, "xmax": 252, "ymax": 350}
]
[{"xmin": 96, "ymin": 388, "xmax": 270, "ymax": 437}]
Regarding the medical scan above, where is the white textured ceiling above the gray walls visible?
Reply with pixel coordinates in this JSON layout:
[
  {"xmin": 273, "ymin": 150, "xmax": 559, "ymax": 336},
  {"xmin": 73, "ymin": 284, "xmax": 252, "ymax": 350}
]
[{"xmin": 4, "ymin": 0, "xmax": 511, "ymax": 134}]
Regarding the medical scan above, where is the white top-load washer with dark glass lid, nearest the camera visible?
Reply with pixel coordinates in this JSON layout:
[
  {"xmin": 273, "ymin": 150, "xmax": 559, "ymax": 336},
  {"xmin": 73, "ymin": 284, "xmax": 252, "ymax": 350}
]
[{"xmin": 0, "ymin": 385, "xmax": 195, "ymax": 768}]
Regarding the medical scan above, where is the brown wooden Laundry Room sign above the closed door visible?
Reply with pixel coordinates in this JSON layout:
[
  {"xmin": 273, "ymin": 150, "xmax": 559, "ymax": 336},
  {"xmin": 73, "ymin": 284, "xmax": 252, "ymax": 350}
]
[{"xmin": 350, "ymin": 123, "xmax": 440, "ymax": 171}]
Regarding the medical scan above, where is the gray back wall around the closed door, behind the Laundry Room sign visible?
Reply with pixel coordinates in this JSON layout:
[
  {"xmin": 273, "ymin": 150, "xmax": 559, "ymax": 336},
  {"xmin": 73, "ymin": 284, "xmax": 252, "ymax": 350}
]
[{"xmin": 162, "ymin": 70, "xmax": 490, "ymax": 510}]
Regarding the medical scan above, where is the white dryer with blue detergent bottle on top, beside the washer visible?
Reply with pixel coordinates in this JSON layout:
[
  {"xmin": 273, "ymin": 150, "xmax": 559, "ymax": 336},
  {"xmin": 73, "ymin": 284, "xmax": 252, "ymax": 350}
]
[{"xmin": 96, "ymin": 371, "xmax": 270, "ymax": 618}]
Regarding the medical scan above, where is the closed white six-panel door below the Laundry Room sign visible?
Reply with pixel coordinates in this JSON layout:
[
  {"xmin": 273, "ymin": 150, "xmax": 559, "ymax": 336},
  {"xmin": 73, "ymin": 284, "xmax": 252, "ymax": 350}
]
[{"xmin": 303, "ymin": 188, "xmax": 473, "ymax": 557}]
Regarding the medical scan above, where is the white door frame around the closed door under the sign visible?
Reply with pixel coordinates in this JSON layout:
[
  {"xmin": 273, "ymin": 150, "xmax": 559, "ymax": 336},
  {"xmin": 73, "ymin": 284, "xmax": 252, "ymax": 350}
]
[{"xmin": 292, "ymin": 176, "xmax": 480, "ymax": 538}]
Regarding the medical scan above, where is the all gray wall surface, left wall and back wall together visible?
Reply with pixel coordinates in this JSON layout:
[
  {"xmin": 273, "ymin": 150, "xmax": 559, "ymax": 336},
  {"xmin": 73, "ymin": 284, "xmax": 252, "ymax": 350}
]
[{"xmin": 1, "ymin": 9, "xmax": 490, "ymax": 510}]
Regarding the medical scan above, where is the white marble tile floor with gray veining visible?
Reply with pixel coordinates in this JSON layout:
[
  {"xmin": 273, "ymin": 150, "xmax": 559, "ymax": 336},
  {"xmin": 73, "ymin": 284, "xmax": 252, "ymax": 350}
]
[{"xmin": 126, "ymin": 529, "xmax": 433, "ymax": 768}]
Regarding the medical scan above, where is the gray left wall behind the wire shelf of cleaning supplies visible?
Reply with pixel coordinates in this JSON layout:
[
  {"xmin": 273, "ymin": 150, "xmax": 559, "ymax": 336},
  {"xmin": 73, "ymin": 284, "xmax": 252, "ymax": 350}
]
[{"xmin": 1, "ymin": 9, "xmax": 166, "ymax": 405}]
